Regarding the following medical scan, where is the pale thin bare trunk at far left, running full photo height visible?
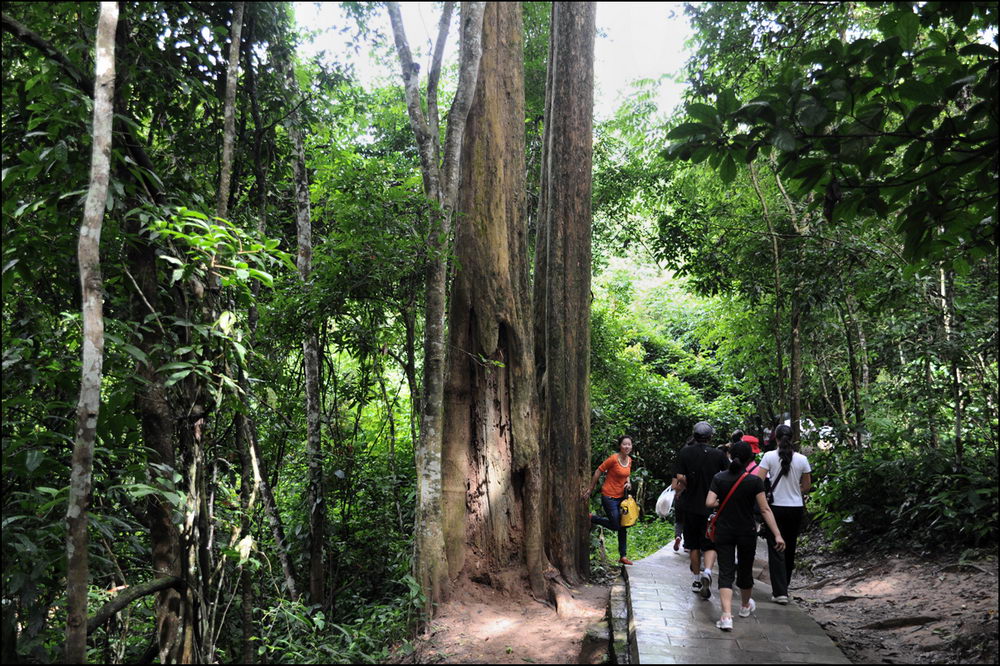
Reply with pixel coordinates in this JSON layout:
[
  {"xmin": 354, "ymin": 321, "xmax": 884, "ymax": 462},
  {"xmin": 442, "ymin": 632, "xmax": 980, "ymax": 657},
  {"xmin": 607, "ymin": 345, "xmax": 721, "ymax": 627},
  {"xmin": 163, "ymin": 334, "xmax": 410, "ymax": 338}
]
[{"xmin": 64, "ymin": 2, "xmax": 118, "ymax": 664}]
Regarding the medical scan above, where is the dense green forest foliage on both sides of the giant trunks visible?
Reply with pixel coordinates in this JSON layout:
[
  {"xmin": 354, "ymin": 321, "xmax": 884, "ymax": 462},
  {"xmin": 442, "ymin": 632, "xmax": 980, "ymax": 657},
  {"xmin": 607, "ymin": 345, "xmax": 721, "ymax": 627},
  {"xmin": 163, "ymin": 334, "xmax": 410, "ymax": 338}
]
[{"xmin": 0, "ymin": 2, "xmax": 1000, "ymax": 663}]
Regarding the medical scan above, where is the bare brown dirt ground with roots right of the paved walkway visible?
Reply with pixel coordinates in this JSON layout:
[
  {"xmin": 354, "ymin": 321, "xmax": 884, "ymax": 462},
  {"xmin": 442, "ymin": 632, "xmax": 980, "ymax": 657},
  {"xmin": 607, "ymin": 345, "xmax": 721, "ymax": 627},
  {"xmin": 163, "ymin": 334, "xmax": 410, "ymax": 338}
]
[{"xmin": 791, "ymin": 530, "xmax": 998, "ymax": 664}]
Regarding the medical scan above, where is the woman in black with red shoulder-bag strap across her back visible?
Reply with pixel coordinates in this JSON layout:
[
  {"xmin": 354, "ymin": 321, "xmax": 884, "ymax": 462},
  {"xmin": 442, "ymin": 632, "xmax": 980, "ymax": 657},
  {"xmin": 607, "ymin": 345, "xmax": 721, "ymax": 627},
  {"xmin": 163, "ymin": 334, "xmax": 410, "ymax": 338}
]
[{"xmin": 705, "ymin": 441, "xmax": 785, "ymax": 631}]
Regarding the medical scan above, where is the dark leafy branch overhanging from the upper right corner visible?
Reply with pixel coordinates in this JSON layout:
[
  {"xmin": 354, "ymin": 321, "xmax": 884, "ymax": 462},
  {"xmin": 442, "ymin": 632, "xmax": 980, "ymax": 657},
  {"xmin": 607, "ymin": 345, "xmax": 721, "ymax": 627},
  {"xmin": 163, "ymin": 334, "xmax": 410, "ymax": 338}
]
[{"xmin": 664, "ymin": 2, "xmax": 998, "ymax": 272}]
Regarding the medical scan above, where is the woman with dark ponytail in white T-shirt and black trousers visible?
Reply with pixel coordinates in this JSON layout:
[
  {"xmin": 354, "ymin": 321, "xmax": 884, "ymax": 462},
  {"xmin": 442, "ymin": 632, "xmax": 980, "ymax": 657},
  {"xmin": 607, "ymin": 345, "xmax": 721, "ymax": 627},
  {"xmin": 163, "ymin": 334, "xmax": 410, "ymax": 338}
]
[{"xmin": 755, "ymin": 424, "xmax": 812, "ymax": 604}]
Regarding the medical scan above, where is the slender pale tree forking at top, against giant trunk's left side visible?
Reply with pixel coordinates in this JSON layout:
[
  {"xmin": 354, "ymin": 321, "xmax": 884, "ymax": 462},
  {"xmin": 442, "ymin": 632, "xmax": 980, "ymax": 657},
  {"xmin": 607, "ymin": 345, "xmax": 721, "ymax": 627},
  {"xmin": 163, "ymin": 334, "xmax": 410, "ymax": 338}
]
[{"xmin": 388, "ymin": 2, "xmax": 485, "ymax": 614}]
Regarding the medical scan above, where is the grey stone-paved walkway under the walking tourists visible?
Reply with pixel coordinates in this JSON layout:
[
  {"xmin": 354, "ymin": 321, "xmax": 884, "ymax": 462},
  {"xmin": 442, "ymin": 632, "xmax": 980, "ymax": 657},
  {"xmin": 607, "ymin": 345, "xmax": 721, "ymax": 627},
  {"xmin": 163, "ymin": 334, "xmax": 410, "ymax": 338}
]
[{"xmin": 625, "ymin": 540, "xmax": 851, "ymax": 664}]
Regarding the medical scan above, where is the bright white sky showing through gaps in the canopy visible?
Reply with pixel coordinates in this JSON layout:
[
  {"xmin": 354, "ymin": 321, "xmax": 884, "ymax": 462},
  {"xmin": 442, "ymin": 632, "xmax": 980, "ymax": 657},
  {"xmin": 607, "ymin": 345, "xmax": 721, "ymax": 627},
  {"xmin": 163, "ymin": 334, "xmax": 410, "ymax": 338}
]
[{"xmin": 294, "ymin": 2, "xmax": 690, "ymax": 120}]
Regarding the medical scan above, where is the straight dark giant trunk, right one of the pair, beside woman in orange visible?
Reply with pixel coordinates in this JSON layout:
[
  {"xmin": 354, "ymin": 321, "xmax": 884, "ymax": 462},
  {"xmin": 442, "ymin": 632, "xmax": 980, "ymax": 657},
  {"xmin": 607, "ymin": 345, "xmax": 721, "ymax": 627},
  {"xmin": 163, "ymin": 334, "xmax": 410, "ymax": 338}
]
[{"xmin": 534, "ymin": 2, "xmax": 595, "ymax": 582}]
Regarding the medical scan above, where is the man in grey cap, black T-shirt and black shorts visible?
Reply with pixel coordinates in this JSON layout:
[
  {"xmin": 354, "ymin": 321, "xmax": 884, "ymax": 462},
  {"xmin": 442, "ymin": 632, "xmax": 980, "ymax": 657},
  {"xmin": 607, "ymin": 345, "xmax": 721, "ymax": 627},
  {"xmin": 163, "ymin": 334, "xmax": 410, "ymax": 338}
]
[{"xmin": 675, "ymin": 421, "xmax": 729, "ymax": 599}]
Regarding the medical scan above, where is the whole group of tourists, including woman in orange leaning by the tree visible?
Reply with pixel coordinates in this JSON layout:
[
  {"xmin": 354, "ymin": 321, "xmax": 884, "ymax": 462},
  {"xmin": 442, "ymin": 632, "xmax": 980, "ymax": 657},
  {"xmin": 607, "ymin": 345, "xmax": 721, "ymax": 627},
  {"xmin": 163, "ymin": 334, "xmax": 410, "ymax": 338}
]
[{"xmin": 583, "ymin": 421, "xmax": 812, "ymax": 631}]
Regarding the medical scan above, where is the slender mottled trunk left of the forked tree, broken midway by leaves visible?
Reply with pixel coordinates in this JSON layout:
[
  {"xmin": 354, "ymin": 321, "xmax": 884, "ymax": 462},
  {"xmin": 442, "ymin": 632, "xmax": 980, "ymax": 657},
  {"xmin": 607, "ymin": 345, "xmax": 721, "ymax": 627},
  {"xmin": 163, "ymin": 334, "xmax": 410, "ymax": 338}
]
[{"xmin": 285, "ymin": 49, "xmax": 326, "ymax": 604}]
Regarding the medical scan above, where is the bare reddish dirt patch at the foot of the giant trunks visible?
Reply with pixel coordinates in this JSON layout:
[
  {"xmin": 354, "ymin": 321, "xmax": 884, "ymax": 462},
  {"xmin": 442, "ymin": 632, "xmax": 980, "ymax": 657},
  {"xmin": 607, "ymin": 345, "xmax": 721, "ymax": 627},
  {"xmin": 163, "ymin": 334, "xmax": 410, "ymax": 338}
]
[{"xmin": 391, "ymin": 582, "xmax": 609, "ymax": 664}]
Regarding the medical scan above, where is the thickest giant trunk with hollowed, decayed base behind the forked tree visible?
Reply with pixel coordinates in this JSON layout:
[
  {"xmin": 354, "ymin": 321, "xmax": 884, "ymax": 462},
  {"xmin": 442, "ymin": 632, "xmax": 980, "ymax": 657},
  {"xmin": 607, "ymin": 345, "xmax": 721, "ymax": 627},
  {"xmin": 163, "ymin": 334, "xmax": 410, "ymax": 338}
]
[{"xmin": 442, "ymin": 3, "xmax": 546, "ymax": 598}]
